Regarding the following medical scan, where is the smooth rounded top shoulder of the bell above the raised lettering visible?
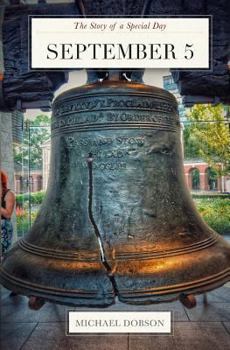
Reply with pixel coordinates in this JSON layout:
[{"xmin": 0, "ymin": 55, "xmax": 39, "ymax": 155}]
[{"xmin": 53, "ymin": 80, "xmax": 178, "ymax": 107}]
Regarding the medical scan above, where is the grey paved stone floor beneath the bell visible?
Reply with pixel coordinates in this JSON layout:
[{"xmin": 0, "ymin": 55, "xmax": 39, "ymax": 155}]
[{"xmin": 1, "ymin": 283, "xmax": 230, "ymax": 350}]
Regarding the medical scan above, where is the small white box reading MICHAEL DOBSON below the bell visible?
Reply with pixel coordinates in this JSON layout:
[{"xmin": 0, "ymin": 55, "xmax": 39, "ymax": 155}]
[{"xmin": 68, "ymin": 311, "xmax": 171, "ymax": 334}]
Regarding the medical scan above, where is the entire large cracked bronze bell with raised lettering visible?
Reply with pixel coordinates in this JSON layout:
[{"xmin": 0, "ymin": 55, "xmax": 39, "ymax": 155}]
[{"xmin": 1, "ymin": 72, "xmax": 230, "ymax": 306}]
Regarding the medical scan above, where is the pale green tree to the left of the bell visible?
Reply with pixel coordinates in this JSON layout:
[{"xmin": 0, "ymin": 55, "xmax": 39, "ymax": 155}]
[{"xmin": 14, "ymin": 114, "xmax": 51, "ymax": 169}]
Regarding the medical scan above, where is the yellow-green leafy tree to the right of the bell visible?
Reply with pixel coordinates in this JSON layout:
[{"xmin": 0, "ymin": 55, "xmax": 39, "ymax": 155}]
[{"xmin": 184, "ymin": 104, "xmax": 230, "ymax": 174}]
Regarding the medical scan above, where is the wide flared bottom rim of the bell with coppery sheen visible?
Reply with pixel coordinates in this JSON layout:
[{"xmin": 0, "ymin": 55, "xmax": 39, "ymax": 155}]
[{"xmin": 0, "ymin": 237, "xmax": 230, "ymax": 307}]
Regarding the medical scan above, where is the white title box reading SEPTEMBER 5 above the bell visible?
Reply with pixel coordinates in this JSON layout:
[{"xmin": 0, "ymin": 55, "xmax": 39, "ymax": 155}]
[{"xmin": 31, "ymin": 17, "xmax": 209, "ymax": 69}]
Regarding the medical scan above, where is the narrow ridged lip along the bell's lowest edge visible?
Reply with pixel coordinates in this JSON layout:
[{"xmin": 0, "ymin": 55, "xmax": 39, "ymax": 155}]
[{"xmin": 0, "ymin": 267, "xmax": 230, "ymax": 307}]
